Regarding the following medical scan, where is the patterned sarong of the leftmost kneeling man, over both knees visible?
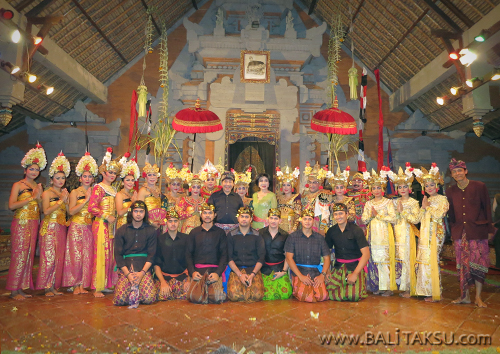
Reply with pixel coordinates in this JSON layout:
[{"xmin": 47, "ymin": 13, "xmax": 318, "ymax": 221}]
[{"xmin": 113, "ymin": 272, "xmax": 156, "ymax": 306}]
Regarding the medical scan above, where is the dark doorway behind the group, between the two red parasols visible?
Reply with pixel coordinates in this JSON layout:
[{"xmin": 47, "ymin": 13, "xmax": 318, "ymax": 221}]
[{"xmin": 228, "ymin": 137, "xmax": 276, "ymax": 197}]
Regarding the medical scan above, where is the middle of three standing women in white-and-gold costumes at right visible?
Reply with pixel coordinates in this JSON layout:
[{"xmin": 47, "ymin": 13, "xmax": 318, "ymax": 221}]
[{"xmin": 389, "ymin": 162, "xmax": 421, "ymax": 298}]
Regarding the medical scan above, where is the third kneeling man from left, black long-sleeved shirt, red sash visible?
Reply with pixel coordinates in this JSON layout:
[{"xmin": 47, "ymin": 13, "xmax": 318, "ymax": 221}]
[{"xmin": 186, "ymin": 203, "xmax": 228, "ymax": 304}]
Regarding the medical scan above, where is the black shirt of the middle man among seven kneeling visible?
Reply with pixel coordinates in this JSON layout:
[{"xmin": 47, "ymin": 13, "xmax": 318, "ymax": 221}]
[{"xmin": 227, "ymin": 227, "xmax": 266, "ymax": 273}]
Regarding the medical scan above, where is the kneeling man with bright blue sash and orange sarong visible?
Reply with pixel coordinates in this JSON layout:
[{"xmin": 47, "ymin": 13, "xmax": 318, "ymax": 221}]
[{"xmin": 285, "ymin": 209, "xmax": 330, "ymax": 302}]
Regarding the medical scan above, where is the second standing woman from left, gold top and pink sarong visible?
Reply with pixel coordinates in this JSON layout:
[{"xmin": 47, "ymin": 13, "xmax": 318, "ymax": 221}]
[{"xmin": 36, "ymin": 151, "xmax": 70, "ymax": 297}]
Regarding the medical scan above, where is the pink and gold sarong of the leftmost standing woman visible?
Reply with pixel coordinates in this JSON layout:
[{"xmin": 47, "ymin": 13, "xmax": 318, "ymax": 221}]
[{"xmin": 6, "ymin": 218, "xmax": 40, "ymax": 291}]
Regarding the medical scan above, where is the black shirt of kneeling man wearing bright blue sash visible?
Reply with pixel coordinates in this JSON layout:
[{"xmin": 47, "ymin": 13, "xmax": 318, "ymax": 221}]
[{"xmin": 285, "ymin": 230, "xmax": 330, "ymax": 279}]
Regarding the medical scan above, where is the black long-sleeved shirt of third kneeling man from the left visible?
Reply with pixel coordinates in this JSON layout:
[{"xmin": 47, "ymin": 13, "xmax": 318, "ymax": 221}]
[{"xmin": 186, "ymin": 224, "xmax": 228, "ymax": 276}]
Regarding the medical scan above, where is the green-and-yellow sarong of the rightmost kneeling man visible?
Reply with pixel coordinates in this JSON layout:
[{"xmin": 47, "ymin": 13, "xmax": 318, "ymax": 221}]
[{"xmin": 325, "ymin": 264, "xmax": 368, "ymax": 301}]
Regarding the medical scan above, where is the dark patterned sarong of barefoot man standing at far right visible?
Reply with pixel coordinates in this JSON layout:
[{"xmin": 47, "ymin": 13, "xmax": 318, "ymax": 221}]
[{"xmin": 455, "ymin": 229, "xmax": 490, "ymax": 299}]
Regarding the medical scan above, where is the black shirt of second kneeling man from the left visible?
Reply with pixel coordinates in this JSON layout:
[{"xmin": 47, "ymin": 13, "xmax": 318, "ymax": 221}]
[{"xmin": 154, "ymin": 231, "xmax": 189, "ymax": 281}]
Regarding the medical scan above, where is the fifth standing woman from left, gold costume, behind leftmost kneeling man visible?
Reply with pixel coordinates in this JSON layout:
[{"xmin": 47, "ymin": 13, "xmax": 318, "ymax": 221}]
[{"xmin": 115, "ymin": 159, "xmax": 140, "ymax": 230}]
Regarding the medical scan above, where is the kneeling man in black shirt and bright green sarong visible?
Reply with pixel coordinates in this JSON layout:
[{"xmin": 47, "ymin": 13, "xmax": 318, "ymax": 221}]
[{"xmin": 259, "ymin": 208, "xmax": 292, "ymax": 300}]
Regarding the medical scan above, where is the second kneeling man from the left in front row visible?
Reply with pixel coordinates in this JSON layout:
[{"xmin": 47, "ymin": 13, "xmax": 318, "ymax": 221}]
[{"xmin": 154, "ymin": 209, "xmax": 189, "ymax": 301}]
